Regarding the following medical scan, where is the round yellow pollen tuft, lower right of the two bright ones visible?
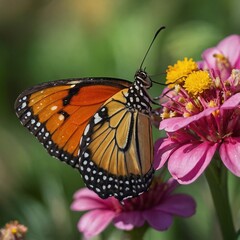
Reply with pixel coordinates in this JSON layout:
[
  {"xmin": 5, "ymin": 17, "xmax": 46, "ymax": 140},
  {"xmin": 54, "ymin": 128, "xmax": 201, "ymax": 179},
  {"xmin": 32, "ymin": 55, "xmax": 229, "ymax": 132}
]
[{"xmin": 183, "ymin": 70, "xmax": 212, "ymax": 96}]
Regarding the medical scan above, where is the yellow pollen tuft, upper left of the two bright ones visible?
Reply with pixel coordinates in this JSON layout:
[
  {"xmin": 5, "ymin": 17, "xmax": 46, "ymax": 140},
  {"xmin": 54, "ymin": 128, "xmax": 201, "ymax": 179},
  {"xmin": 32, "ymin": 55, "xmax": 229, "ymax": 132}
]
[{"xmin": 166, "ymin": 58, "xmax": 198, "ymax": 88}]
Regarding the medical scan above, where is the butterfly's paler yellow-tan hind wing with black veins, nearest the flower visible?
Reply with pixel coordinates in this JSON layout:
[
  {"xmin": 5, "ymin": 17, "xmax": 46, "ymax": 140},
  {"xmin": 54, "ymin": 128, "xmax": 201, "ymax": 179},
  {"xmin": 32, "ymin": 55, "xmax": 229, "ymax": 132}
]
[{"xmin": 80, "ymin": 89, "xmax": 154, "ymax": 200}]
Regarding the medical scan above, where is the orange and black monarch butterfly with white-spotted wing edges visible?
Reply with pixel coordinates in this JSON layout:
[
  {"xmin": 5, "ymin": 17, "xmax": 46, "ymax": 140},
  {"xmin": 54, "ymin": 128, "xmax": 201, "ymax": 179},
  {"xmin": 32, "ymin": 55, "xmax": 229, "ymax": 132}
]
[{"xmin": 15, "ymin": 27, "xmax": 164, "ymax": 201}]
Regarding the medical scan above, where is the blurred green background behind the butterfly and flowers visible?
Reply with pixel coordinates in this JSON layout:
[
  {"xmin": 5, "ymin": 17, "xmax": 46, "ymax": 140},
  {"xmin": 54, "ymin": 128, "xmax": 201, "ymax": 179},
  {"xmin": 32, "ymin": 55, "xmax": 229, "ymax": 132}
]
[{"xmin": 0, "ymin": 0, "xmax": 240, "ymax": 240}]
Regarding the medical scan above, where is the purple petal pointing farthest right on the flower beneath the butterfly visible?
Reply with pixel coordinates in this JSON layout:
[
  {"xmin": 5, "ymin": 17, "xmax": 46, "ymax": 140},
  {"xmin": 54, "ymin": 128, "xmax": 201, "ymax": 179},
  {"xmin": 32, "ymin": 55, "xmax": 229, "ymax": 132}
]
[{"xmin": 156, "ymin": 194, "xmax": 196, "ymax": 217}]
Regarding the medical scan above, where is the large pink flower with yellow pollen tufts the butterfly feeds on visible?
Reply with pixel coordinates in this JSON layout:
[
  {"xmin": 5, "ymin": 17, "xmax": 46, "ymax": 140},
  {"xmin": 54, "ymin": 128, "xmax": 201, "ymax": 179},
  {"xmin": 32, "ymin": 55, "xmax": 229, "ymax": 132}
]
[{"xmin": 155, "ymin": 35, "xmax": 240, "ymax": 184}]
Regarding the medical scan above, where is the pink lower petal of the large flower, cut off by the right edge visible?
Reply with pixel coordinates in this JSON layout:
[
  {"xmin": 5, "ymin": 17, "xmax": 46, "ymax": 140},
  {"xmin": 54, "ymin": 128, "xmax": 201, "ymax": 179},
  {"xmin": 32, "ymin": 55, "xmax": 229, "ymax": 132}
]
[{"xmin": 219, "ymin": 137, "xmax": 240, "ymax": 177}]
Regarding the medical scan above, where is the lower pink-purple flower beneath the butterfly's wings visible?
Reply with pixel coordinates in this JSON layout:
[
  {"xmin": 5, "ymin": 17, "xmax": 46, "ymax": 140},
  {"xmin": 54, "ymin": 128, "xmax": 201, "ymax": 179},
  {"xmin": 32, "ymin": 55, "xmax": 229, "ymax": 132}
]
[{"xmin": 71, "ymin": 179, "xmax": 196, "ymax": 238}]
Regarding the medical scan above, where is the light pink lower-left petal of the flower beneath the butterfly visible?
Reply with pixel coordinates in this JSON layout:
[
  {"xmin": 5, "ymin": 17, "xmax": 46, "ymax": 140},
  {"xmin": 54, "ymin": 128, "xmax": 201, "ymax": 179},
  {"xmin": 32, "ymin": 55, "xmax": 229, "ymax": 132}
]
[{"xmin": 78, "ymin": 210, "xmax": 115, "ymax": 238}]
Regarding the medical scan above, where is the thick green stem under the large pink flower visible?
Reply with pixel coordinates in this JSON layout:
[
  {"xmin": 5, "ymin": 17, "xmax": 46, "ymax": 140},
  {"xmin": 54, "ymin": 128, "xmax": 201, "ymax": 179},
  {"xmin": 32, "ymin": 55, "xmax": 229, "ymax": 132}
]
[{"xmin": 205, "ymin": 158, "xmax": 237, "ymax": 240}]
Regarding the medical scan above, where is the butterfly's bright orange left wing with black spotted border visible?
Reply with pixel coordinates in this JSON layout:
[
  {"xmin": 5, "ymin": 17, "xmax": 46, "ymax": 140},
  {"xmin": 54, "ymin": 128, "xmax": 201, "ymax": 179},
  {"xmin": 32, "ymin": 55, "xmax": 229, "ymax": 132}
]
[{"xmin": 15, "ymin": 78, "xmax": 131, "ymax": 167}]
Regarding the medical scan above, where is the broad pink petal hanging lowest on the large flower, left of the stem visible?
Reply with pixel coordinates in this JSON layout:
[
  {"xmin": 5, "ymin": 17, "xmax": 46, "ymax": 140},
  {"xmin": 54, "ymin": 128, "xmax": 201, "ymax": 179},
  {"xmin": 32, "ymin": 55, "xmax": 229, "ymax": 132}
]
[{"xmin": 168, "ymin": 142, "xmax": 218, "ymax": 184}]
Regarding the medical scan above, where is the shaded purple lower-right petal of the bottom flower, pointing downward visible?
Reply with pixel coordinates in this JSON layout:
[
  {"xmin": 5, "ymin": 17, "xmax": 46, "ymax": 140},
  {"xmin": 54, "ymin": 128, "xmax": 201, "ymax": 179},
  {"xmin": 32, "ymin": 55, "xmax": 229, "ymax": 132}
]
[{"xmin": 143, "ymin": 210, "xmax": 173, "ymax": 231}]
